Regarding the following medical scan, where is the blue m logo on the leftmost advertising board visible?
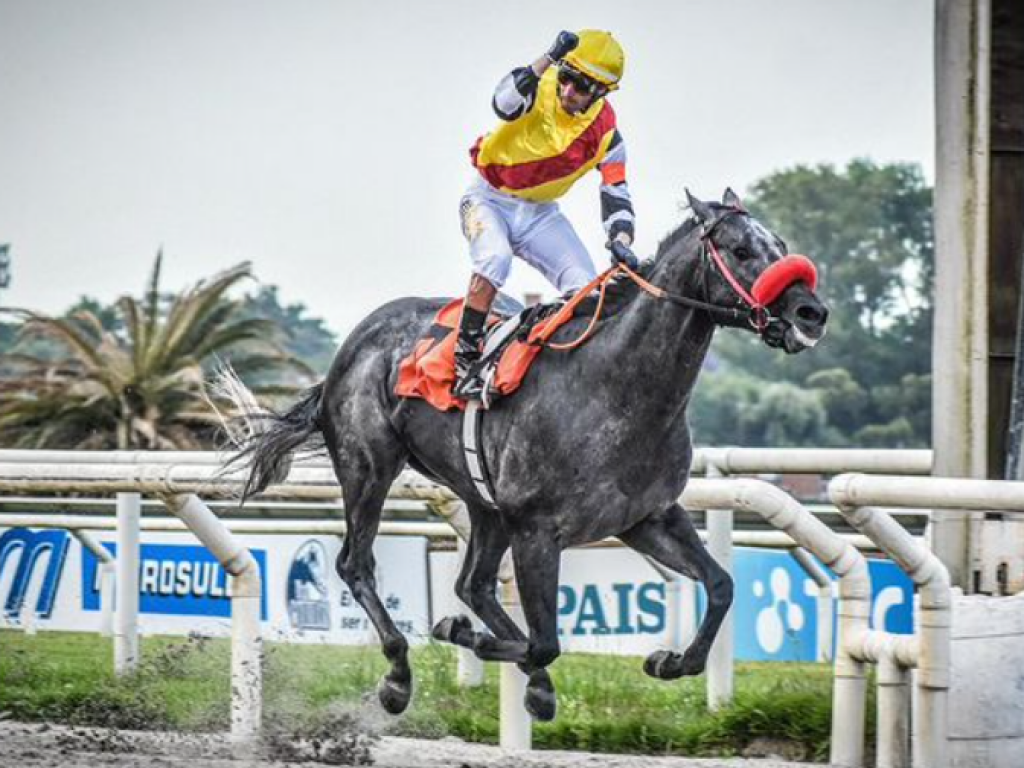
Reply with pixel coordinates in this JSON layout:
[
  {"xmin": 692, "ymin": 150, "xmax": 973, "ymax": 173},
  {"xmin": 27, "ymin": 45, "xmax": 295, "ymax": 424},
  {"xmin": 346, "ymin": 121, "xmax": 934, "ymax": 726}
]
[{"xmin": 0, "ymin": 528, "xmax": 69, "ymax": 618}]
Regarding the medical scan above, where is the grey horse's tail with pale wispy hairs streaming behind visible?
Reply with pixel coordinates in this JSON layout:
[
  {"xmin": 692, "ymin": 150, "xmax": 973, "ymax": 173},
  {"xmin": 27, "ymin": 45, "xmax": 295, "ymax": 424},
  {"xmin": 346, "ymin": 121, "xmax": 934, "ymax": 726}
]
[{"xmin": 213, "ymin": 367, "xmax": 324, "ymax": 502}]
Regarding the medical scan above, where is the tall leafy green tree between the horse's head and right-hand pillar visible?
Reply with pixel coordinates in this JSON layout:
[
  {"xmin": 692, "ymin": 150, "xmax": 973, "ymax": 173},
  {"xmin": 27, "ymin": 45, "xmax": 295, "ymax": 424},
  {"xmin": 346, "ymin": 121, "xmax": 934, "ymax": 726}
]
[{"xmin": 694, "ymin": 160, "xmax": 934, "ymax": 446}]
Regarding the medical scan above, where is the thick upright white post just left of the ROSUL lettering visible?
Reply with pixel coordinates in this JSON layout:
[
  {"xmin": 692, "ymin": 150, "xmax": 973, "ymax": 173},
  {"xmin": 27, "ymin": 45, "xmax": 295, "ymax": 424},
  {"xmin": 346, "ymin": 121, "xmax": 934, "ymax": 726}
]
[{"xmin": 114, "ymin": 494, "xmax": 142, "ymax": 675}]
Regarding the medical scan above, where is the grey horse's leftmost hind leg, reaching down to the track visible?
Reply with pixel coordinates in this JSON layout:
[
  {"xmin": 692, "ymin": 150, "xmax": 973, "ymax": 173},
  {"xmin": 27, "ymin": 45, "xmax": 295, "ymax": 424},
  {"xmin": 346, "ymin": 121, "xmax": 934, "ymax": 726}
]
[{"xmin": 327, "ymin": 418, "xmax": 413, "ymax": 715}]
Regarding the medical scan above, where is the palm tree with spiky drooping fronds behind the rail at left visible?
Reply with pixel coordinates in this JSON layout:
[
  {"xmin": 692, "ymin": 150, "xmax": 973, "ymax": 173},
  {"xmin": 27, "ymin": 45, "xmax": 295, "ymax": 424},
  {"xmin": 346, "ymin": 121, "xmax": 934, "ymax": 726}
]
[{"xmin": 0, "ymin": 253, "xmax": 310, "ymax": 450}]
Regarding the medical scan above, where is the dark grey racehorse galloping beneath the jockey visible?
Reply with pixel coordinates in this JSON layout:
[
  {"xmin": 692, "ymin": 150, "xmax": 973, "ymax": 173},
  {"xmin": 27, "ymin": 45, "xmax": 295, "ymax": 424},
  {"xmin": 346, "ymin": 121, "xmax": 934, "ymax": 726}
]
[{"xmin": 228, "ymin": 190, "xmax": 827, "ymax": 720}]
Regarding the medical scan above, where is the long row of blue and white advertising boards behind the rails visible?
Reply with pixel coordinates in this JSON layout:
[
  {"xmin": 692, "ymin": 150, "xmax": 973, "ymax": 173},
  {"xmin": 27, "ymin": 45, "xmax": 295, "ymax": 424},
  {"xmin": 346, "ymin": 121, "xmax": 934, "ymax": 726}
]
[{"xmin": 0, "ymin": 528, "xmax": 913, "ymax": 662}]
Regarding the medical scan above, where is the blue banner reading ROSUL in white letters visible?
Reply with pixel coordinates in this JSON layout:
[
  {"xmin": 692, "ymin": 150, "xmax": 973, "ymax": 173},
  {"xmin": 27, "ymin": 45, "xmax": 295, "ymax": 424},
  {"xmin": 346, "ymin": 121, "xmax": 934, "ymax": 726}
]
[{"xmin": 82, "ymin": 542, "xmax": 267, "ymax": 621}]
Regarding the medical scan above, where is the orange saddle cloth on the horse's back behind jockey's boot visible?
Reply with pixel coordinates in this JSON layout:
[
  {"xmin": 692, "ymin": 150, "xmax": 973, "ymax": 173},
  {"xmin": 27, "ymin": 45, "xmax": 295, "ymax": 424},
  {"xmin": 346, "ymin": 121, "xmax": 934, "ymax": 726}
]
[{"xmin": 394, "ymin": 299, "xmax": 574, "ymax": 411}]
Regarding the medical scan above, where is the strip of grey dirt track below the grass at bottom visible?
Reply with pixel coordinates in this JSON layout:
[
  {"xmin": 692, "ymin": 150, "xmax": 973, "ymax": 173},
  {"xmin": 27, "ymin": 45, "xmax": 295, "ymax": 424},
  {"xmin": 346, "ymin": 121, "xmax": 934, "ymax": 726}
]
[{"xmin": 0, "ymin": 722, "xmax": 812, "ymax": 768}]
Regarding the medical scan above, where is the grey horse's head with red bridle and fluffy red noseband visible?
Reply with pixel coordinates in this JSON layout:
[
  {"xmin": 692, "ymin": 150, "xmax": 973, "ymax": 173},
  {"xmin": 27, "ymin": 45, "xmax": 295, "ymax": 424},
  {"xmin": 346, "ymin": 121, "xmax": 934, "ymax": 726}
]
[{"xmin": 686, "ymin": 189, "xmax": 828, "ymax": 354}]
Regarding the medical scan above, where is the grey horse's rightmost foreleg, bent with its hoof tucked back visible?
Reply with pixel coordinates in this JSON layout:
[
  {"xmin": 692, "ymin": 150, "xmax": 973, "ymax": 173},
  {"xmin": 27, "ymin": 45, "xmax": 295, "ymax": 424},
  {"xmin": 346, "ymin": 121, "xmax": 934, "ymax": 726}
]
[{"xmin": 618, "ymin": 504, "xmax": 732, "ymax": 680}]
